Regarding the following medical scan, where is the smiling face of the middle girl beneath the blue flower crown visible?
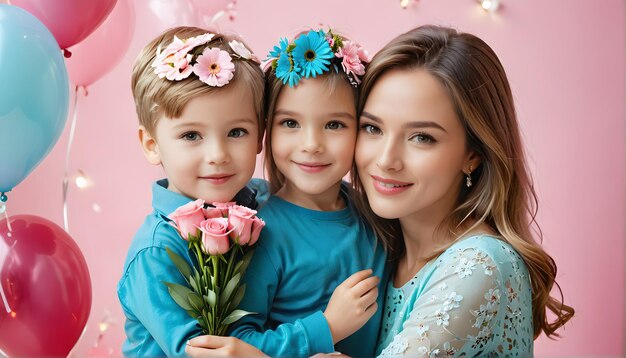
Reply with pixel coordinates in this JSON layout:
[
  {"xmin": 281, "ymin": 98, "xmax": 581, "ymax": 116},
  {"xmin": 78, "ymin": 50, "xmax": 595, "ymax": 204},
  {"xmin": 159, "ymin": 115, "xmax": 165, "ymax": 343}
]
[{"xmin": 269, "ymin": 77, "xmax": 357, "ymax": 203}]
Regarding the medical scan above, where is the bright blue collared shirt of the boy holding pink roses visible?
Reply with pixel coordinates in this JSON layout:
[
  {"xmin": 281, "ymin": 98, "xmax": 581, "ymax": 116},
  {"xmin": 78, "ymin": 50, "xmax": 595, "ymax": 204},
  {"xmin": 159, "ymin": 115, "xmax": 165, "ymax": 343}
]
[{"xmin": 117, "ymin": 179, "xmax": 268, "ymax": 357}]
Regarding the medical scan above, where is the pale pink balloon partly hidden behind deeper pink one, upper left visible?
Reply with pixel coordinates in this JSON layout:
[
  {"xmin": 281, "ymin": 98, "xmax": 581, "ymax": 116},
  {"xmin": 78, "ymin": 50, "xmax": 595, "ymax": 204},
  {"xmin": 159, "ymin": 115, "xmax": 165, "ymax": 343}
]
[{"xmin": 65, "ymin": 0, "xmax": 135, "ymax": 87}]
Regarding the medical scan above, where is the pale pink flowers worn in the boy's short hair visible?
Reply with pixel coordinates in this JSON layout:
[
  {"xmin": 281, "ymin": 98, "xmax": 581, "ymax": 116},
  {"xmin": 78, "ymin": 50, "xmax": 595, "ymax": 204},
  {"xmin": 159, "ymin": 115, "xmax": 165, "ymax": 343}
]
[{"xmin": 152, "ymin": 33, "xmax": 259, "ymax": 87}]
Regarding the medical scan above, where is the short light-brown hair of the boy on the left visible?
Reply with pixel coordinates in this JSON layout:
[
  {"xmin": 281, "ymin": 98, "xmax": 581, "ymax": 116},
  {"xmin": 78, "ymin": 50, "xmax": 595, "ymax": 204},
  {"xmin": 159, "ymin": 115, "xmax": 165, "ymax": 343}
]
[{"xmin": 131, "ymin": 26, "xmax": 265, "ymax": 140}]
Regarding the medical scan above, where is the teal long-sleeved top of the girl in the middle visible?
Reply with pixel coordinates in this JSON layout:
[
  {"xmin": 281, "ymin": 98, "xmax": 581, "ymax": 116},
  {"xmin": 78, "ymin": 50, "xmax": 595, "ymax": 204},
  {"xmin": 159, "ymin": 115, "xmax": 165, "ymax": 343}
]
[{"xmin": 231, "ymin": 187, "xmax": 387, "ymax": 357}]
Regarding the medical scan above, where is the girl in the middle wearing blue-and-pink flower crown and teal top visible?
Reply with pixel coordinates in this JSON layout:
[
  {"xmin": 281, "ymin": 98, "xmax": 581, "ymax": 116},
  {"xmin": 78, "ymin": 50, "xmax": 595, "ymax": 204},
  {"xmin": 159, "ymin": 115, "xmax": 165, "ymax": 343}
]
[{"xmin": 222, "ymin": 30, "xmax": 385, "ymax": 357}]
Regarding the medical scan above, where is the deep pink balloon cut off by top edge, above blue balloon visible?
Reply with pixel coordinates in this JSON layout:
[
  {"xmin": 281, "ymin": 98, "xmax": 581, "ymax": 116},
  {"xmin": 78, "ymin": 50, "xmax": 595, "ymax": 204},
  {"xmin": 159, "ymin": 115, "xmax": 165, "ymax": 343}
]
[{"xmin": 11, "ymin": 0, "xmax": 117, "ymax": 49}]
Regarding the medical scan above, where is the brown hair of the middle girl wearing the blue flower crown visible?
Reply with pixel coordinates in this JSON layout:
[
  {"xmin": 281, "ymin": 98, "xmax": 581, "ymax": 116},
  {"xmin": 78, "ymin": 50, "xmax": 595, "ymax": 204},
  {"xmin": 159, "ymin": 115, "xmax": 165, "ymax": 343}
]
[{"xmin": 263, "ymin": 30, "xmax": 367, "ymax": 194}]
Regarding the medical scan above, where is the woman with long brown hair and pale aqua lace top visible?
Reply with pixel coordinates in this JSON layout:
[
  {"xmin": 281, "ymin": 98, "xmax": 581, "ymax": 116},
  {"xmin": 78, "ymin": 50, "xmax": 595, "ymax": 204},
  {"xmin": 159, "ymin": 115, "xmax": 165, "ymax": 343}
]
[{"xmin": 353, "ymin": 26, "xmax": 574, "ymax": 357}]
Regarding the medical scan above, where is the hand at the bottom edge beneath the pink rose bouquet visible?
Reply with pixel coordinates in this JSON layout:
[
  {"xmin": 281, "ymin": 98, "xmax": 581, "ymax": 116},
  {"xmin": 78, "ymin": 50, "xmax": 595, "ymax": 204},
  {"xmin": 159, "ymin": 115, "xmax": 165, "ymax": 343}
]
[{"xmin": 185, "ymin": 336, "xmax": 267, "ymax": 357}]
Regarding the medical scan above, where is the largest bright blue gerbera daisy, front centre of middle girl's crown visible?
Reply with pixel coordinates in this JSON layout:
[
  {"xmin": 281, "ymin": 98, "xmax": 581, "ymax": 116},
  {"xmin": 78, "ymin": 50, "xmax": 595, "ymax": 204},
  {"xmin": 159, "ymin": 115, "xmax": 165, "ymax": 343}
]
[{"xmin": 293, "ymin": 31, "xmax": 335, "ymax": 78}]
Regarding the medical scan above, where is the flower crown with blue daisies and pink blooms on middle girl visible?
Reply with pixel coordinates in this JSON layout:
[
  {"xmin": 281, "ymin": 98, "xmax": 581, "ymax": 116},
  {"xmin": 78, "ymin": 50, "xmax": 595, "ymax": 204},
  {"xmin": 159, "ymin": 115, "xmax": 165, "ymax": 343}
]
[{"xmin": 261, "ymin": 30, "xmax": 369, "ymax": 87}]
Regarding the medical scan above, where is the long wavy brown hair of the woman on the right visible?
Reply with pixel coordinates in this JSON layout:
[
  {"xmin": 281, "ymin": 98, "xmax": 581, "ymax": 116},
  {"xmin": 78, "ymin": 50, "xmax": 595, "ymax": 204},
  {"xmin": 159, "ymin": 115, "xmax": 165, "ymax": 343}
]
[{"xmin": 352, "ymin": 26, "xmax": 574, "ymax": 337}]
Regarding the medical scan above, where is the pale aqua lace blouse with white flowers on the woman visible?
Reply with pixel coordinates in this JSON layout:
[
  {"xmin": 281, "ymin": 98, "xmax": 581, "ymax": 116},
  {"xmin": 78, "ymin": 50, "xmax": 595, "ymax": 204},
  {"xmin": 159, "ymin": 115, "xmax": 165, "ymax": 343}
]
[{"xmin": 376, "ymin": 235, "xmax": 533, "ymax": 357}]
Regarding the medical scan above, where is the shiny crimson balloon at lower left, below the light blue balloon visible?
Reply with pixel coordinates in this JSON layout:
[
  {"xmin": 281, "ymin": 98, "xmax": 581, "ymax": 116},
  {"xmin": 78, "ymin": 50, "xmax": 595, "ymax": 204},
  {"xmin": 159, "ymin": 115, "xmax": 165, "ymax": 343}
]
[{"xmin": 0, "ymin": 215, "xmax": 91, "ymax": 357}]
